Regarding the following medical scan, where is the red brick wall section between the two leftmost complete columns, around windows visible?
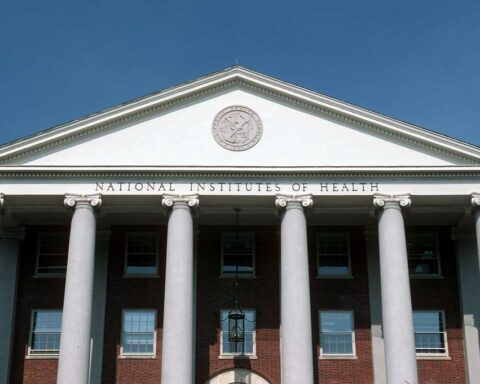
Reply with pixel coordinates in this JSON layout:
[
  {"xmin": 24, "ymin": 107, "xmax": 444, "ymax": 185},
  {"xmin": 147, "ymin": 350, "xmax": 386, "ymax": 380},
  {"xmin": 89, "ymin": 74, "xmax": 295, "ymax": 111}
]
[{"xmin": 102, "ymin": 227, "xmax": 166, "ymax": 384}]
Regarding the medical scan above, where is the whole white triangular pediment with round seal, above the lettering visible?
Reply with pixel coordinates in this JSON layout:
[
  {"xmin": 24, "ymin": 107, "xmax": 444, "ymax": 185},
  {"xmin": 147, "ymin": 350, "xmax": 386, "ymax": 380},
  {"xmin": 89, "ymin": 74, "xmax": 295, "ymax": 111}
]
[{"xmin": 0, "ymin": 67, "xmax": 480, "ymax": 169}]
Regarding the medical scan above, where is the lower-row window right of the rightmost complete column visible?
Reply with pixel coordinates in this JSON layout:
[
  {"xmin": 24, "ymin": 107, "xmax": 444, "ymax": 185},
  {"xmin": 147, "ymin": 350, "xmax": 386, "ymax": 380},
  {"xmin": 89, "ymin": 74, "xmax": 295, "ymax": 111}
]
[{"xmin": 413, "ymin": 311, "xmax": 447, "ymax": 356}]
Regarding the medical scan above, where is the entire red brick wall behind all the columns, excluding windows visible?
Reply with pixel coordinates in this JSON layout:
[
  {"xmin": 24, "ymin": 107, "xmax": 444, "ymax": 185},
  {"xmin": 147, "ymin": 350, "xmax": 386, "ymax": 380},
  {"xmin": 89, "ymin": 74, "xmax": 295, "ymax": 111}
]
[{"xmin": 11, "ymin": 226, "xmax": 466, "ymax": 384}]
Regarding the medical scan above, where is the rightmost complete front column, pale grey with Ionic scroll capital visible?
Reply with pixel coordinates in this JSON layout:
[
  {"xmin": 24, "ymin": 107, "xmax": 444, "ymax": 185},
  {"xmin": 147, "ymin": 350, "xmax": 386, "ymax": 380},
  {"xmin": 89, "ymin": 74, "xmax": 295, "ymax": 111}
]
[{"xmin": 373, "ymin": 195, "xmax": 418, "ymax": 384}]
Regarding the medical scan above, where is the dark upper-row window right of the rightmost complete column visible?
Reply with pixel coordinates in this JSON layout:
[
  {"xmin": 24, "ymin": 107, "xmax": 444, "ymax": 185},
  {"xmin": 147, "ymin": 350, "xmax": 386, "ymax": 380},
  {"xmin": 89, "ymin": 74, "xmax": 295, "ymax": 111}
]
[{"xmin": 407, "ymin": 233, "xmax": 440, "ymax": 275}]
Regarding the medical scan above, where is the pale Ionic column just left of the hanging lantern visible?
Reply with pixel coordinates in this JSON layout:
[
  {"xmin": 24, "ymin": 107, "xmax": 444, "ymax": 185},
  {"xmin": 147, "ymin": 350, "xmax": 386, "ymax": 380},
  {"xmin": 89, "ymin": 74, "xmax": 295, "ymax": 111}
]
[{"xmin": 162, "ymin": 196, "xmax": 198, "ymax": 384}]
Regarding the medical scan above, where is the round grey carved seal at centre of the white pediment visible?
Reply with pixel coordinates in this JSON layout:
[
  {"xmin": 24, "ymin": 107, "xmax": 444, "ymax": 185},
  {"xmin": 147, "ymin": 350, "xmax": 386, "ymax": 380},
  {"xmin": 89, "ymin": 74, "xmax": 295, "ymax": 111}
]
[{"xmin": 212, "ymin": 105, "xmax": 263, "ymax": 151}]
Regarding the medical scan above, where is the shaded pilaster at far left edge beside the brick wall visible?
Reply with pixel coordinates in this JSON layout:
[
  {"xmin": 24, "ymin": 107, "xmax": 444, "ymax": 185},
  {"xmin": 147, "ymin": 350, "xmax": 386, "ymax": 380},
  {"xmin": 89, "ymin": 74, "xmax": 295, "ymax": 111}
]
[{"xmin": 0, "ymin": 218, "xmax": 24, "ymax": 383}]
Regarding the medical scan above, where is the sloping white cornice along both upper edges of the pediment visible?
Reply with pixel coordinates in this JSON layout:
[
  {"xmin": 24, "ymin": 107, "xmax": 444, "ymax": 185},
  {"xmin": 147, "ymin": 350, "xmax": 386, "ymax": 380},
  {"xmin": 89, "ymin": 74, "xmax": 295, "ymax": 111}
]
[{"xmin": 0, "ymin": 66, "xmax": 480, "ymax": 163}]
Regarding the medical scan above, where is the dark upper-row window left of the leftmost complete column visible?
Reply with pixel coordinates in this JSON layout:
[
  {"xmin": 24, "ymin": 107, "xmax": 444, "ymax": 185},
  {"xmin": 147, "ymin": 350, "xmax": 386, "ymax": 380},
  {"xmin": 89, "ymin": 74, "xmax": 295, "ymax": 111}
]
[{"xmin": 37, "ymin": 232, "xmax": 68, "ymax": 275}]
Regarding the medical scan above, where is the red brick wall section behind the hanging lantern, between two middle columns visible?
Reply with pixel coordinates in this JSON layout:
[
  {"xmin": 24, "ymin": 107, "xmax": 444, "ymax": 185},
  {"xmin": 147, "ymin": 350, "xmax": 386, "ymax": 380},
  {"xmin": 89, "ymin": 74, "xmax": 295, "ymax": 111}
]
[{"xmin": 196, "ymin": 227, "xmax": 280, "ymax": 384}]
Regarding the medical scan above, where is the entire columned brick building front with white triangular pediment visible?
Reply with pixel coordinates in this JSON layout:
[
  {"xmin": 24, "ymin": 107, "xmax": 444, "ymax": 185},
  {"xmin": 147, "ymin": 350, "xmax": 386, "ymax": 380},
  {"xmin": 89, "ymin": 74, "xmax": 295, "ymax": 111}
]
[{"xmin": 0, "ymin": 67, "xmax": 480, "ymax": 384}]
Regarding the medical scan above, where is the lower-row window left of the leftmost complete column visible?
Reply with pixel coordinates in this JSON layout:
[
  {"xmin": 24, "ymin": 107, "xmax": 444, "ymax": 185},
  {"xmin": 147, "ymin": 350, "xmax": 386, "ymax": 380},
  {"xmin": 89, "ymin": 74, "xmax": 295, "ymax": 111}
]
[{"xmin": 29, "ymin": 310, "xmax": 62, "ymax": 355}]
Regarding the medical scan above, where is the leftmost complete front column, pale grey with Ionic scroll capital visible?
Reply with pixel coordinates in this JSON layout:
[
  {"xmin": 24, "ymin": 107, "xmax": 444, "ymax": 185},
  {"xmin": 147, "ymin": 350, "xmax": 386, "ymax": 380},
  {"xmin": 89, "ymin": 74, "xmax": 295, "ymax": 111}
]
[{"xmin": 57, "ymin": 195, "xmax": 101, "ymax": 384}]
